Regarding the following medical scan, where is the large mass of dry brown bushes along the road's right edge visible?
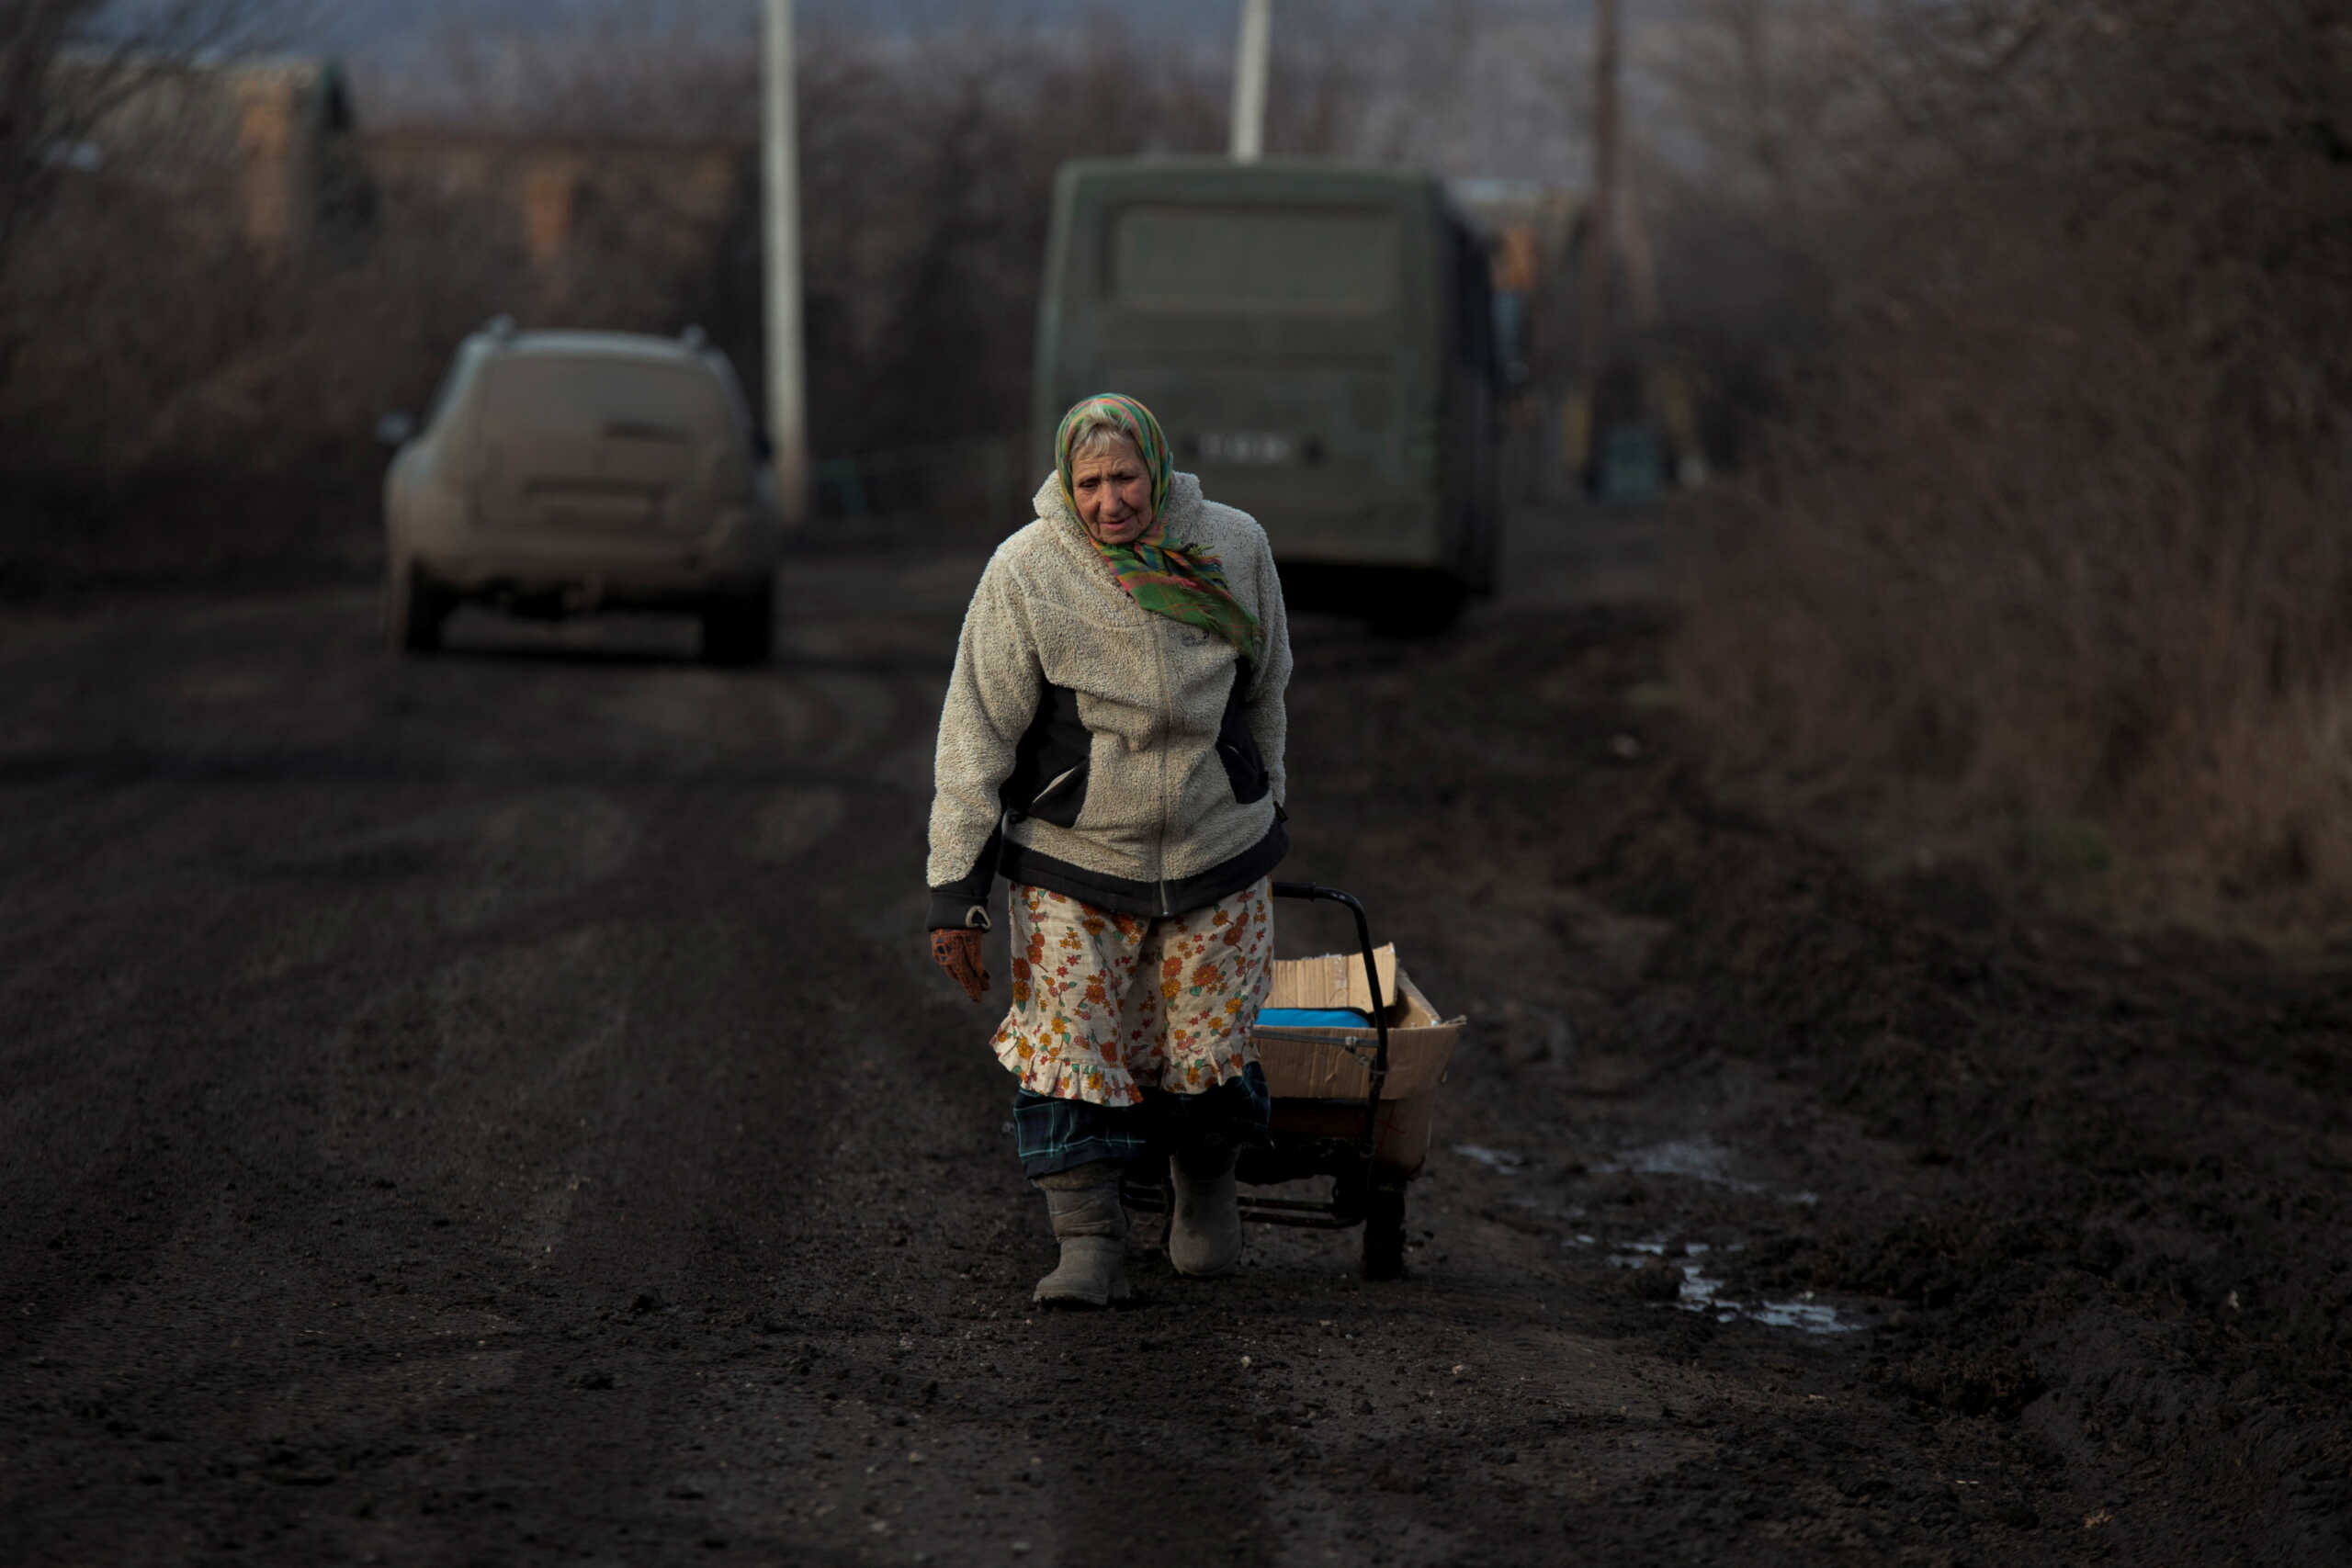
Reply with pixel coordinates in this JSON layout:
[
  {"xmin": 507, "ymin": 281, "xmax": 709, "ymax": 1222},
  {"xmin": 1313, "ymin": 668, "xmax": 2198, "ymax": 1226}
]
[{"xmin": 1677, "ymin": 0, "xmax": 2352, "ymax": 919}]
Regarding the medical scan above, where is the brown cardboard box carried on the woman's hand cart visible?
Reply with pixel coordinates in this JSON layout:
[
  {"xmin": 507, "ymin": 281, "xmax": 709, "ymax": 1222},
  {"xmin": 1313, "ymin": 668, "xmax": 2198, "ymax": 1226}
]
[{"xmin": 1249, "ymin": 945, "xmax": 1463, "ymax": 1176}]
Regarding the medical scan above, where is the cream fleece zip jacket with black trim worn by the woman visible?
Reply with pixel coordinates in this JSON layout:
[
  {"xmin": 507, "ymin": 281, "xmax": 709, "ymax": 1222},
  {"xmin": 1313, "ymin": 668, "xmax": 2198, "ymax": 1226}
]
[{"xmin": 924, "ymin": 472, "xmax": 1291, "ymax": 929}]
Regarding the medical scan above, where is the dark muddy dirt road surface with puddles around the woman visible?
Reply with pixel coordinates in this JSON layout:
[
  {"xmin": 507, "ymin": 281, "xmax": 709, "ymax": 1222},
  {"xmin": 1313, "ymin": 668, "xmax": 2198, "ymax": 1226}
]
[{"xmin": 0, "ymin": 517, "xmax": 2352, "ymax": 1565}]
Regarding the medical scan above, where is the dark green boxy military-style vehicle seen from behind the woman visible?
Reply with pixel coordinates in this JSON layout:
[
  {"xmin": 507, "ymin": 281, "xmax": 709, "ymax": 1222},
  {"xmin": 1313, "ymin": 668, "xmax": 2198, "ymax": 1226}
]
[{"xmin": 1033, "ymin": 157, "xmax": 1498, "ymax": 621}]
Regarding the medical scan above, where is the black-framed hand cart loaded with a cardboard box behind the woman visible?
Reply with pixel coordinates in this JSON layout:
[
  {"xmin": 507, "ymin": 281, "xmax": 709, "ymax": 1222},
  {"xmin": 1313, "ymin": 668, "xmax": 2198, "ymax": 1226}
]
[{"xmin": 1125, "ymin": 882, "xmax": 1463, "ymax": 1279}]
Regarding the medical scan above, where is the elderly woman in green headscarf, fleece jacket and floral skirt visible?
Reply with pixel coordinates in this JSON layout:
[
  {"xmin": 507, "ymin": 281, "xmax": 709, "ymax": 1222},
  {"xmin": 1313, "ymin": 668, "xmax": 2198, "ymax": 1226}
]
[{"xmin": 927, "ymin": 395, "xmax": 1291, "ymax": 1307}]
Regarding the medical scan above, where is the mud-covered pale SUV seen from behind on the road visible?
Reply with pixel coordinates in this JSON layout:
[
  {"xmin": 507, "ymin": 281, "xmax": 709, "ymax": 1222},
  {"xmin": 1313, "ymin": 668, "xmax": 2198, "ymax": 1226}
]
[{"xmin": 381, "ymin": 320, "xmax": 783, "ymax": 663}]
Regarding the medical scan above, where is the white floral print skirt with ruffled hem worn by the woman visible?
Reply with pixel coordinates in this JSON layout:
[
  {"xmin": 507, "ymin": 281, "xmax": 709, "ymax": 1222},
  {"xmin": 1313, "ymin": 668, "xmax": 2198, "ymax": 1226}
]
[{"xmin": 990, "ymin": 879, "xmax": 1275, "ymax": 1105}]
